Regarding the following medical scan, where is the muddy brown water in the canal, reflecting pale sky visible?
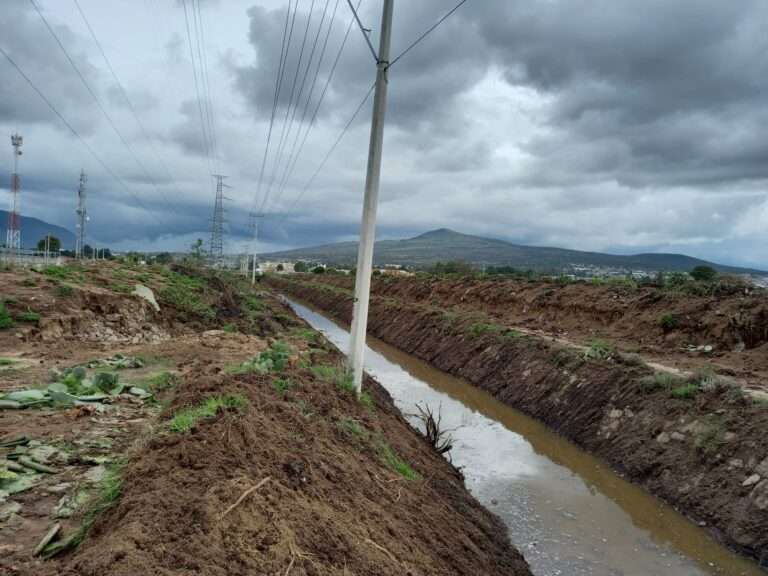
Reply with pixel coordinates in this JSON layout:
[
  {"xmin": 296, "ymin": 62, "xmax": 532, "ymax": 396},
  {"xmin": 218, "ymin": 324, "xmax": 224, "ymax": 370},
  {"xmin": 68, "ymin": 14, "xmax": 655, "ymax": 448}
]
[{"xmin": 289, "ymin": 300, "xmax": 765, "ymax": 576}]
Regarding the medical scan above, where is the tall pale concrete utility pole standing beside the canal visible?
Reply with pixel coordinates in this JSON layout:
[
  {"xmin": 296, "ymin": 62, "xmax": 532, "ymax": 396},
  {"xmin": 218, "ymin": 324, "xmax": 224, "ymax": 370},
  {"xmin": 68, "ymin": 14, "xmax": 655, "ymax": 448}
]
[{"xmin": 349, "ymin": 0, "xmax": 394, "ymax": 394}]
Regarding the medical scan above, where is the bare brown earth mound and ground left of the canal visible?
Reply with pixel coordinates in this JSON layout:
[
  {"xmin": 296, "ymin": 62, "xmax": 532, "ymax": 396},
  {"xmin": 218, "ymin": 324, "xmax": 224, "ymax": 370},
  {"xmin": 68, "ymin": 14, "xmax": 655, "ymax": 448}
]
[{"xmin": 0, "ymin": 266, "xmax": 530, "ymax": 576}]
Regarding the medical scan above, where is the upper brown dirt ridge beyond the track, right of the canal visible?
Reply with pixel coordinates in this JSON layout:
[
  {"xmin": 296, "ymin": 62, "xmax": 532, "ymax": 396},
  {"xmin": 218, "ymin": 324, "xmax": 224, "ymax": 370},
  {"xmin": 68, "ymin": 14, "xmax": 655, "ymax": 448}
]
[{"xmin": 306, "ymin": 276, "xmax": 768, "ymax": 389}]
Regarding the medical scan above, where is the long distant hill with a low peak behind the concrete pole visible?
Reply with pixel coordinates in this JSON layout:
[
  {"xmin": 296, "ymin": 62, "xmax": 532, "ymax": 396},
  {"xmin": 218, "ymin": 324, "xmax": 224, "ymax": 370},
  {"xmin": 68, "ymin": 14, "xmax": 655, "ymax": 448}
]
[{"xmin": 263, "ymin": 228, "xmax": 768, "ymax": 275}]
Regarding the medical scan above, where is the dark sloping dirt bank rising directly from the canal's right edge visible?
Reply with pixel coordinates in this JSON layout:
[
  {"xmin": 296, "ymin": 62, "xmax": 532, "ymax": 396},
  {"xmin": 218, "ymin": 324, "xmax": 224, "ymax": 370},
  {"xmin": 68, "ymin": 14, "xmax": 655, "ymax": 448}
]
[{"xmin": 269, "ymin": 276, "xmax": 768, "ymax": 559}]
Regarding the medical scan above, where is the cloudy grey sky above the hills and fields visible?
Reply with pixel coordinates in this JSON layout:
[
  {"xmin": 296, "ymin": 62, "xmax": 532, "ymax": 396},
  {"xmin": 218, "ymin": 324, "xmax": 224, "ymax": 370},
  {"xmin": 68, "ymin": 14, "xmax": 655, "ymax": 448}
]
[{"xmin": 0, "ymin": 0, "xmax": 768, "ymax": 269}]
